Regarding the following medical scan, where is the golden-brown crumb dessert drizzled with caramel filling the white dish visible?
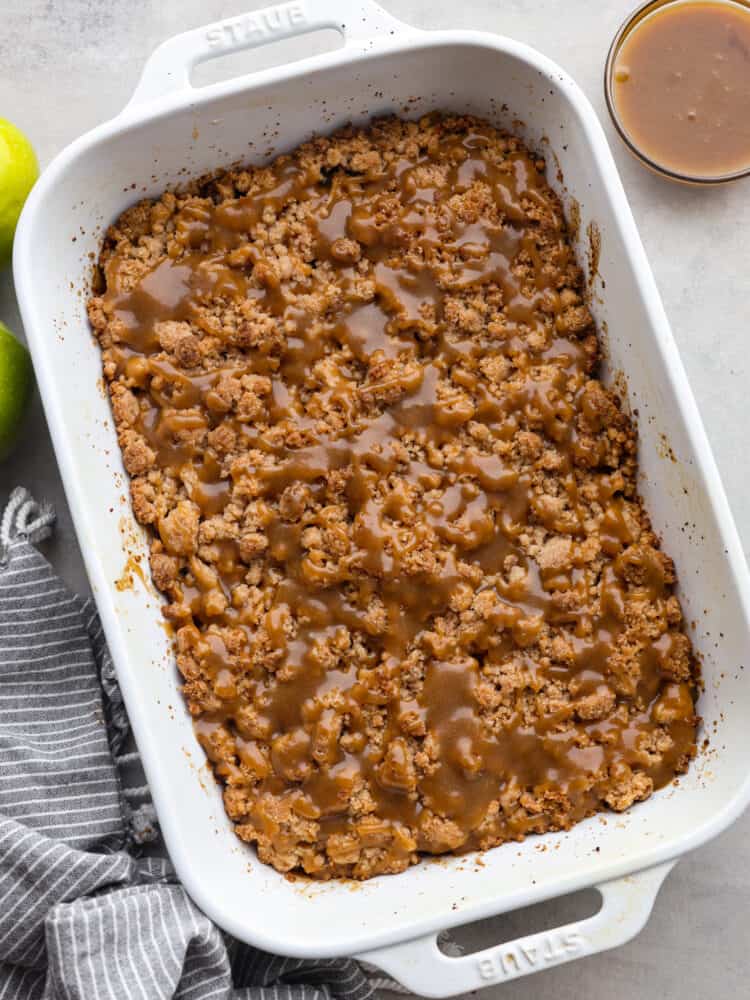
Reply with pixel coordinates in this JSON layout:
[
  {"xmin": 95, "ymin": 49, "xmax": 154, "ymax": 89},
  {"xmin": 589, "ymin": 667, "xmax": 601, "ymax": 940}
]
[{"xmin": 89, "ymin": 115, "xmax": 697, "ymax": 879}]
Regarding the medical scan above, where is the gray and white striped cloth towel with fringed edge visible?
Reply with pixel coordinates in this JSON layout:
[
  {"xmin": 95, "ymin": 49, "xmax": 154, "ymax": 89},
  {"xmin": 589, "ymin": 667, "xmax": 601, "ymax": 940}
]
[{"xmin": 0, "ymin": 489, "xmax": 390, "ymax": 1000}]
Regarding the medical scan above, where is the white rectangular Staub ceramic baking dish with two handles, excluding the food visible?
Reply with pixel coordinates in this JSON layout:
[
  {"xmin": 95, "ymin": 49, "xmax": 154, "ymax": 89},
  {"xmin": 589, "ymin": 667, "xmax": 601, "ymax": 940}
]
[{"xmin": 14, "ymin": 0, "xmax": 750, "ymax": 996}]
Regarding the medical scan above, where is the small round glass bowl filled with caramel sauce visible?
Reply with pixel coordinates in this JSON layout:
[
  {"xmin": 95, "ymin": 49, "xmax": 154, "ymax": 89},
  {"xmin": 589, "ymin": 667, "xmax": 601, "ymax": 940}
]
[{"xmin": 604, "ymin": 0, "xmax": 750, "ymax": 184}]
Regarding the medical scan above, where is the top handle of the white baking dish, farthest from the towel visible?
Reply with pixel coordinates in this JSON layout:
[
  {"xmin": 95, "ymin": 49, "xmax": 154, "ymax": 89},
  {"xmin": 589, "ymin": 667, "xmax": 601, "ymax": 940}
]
[{"xmin": 125, "ymin": 0, "xmax": 413, "ymax": 111}]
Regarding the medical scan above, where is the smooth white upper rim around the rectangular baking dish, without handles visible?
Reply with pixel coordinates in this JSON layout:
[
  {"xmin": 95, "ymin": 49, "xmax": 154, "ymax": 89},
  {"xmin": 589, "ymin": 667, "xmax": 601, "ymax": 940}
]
[{"xmin": 14, "ymin": 13, "xmax": 750, "ymax": 957}]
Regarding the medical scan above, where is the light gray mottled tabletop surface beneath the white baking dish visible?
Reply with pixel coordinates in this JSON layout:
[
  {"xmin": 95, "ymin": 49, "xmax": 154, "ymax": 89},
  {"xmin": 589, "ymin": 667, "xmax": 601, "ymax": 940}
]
[{"xmin": 0, "ymin": 0, "xmax": 750, "ymax": 1000}]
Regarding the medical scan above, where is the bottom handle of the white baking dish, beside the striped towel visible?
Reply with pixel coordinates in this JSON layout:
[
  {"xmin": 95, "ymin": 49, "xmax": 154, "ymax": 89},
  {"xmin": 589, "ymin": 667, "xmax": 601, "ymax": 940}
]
[{"xmin": 357, "ymin": 861, "xmax": 675, "ymax": 997}]
